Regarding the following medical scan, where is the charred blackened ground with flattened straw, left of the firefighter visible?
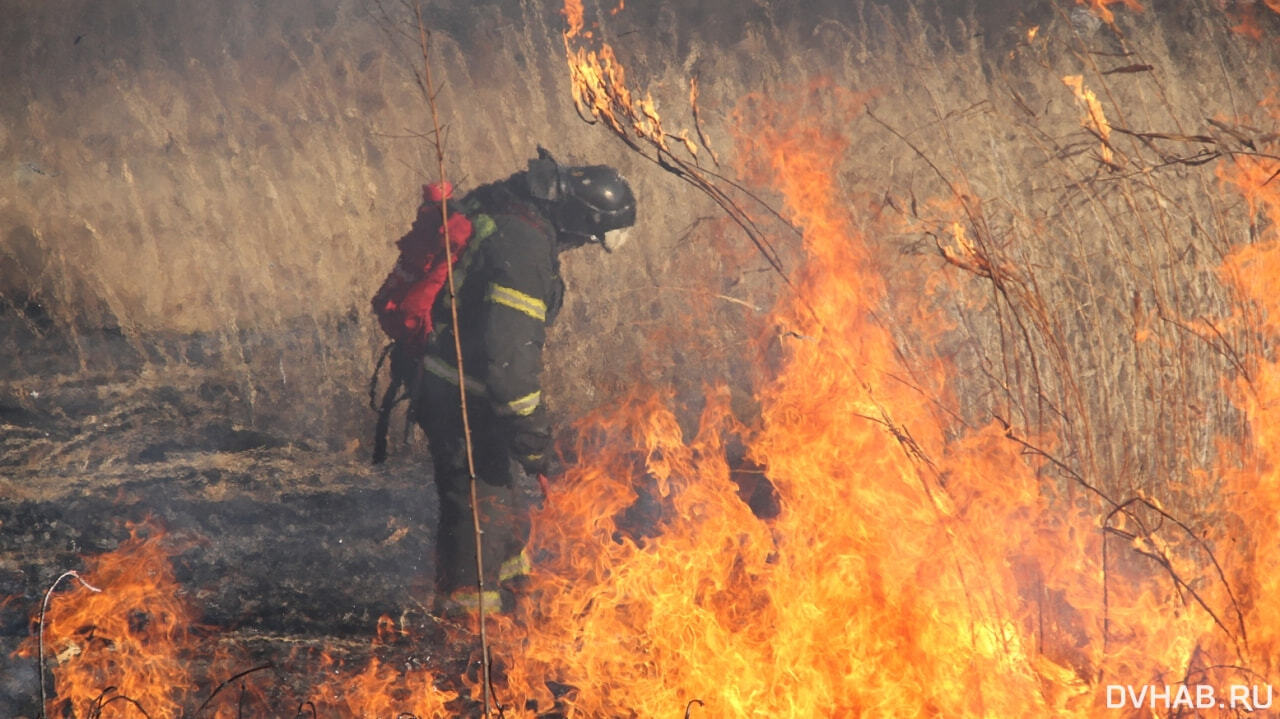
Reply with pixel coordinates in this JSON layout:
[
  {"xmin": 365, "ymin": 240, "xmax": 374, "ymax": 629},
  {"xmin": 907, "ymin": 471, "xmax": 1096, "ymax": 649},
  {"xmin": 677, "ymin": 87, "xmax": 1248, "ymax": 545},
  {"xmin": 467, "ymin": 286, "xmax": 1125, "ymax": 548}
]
[{"xmin": 0, "ymin": 317, "xmax": 460, "ymax": 716}]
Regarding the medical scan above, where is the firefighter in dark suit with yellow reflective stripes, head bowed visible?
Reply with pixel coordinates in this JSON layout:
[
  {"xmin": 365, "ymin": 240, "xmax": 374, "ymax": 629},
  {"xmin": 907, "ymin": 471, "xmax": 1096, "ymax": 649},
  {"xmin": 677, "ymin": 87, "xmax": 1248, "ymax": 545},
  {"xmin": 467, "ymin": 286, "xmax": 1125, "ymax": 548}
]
[{"xmin": 413, "ymin": 148, "xmax": 635, "ymax": 613}]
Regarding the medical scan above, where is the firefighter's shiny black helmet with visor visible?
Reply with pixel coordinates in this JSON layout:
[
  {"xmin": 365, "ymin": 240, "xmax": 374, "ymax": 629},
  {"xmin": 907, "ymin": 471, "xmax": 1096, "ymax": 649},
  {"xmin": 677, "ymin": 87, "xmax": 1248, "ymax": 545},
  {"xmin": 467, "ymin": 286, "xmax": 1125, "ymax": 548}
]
[{"xmin": 529, "ymin": 147, "xmax": 636, "ymax": 249}]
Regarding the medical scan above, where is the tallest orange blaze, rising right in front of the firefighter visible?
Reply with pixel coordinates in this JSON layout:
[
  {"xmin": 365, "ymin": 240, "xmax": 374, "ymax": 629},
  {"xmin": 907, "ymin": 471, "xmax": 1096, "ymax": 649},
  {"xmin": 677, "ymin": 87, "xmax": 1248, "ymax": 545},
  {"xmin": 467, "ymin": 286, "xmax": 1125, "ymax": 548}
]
[{"xmin": 483, "ymin": 86, "xmax": 1098, "ymax": 716}]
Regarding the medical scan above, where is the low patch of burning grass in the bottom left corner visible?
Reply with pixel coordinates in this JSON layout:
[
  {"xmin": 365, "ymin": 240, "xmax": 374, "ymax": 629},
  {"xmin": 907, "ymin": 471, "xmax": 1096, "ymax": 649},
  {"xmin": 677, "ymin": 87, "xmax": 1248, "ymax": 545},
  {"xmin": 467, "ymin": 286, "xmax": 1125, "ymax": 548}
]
[{"xmin": 20, "ymin": 522, "xmax": 461, "ymax": 719}]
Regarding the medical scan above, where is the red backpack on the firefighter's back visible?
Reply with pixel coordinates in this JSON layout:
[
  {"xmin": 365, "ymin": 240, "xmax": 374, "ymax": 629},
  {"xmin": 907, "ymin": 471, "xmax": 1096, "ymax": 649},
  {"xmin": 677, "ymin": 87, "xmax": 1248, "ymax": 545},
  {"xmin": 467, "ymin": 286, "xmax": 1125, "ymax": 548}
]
[{"xmin": 374, "ymin": 182, "xmax": 472, "ymax": 353}]
